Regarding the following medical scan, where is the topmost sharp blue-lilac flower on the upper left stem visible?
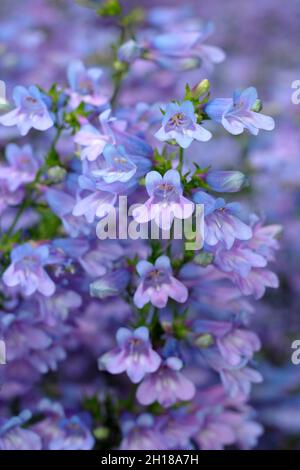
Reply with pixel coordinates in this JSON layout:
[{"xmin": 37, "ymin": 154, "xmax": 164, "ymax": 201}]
[{"xmin": 67, "ymin": 60, "xmax": 108, "ymax": 108}]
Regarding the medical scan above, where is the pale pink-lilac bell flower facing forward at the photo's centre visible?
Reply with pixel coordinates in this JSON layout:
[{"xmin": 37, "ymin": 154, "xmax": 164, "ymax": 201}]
[{"xmin": 133, "ymin": 170, "xmax": 194, "ymax": 230}]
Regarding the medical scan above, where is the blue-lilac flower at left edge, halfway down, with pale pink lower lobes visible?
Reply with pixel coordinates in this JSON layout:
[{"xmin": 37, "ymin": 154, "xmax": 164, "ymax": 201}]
[{"xmin": 3, "ymin": 243, "xmax": 55, "ymax": 296}]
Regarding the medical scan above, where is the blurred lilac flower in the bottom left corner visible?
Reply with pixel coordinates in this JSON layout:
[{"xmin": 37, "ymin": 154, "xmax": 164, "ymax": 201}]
[{"xmin": 0, "ymin": 410, "xmax": 42, "ymax": 450}]
